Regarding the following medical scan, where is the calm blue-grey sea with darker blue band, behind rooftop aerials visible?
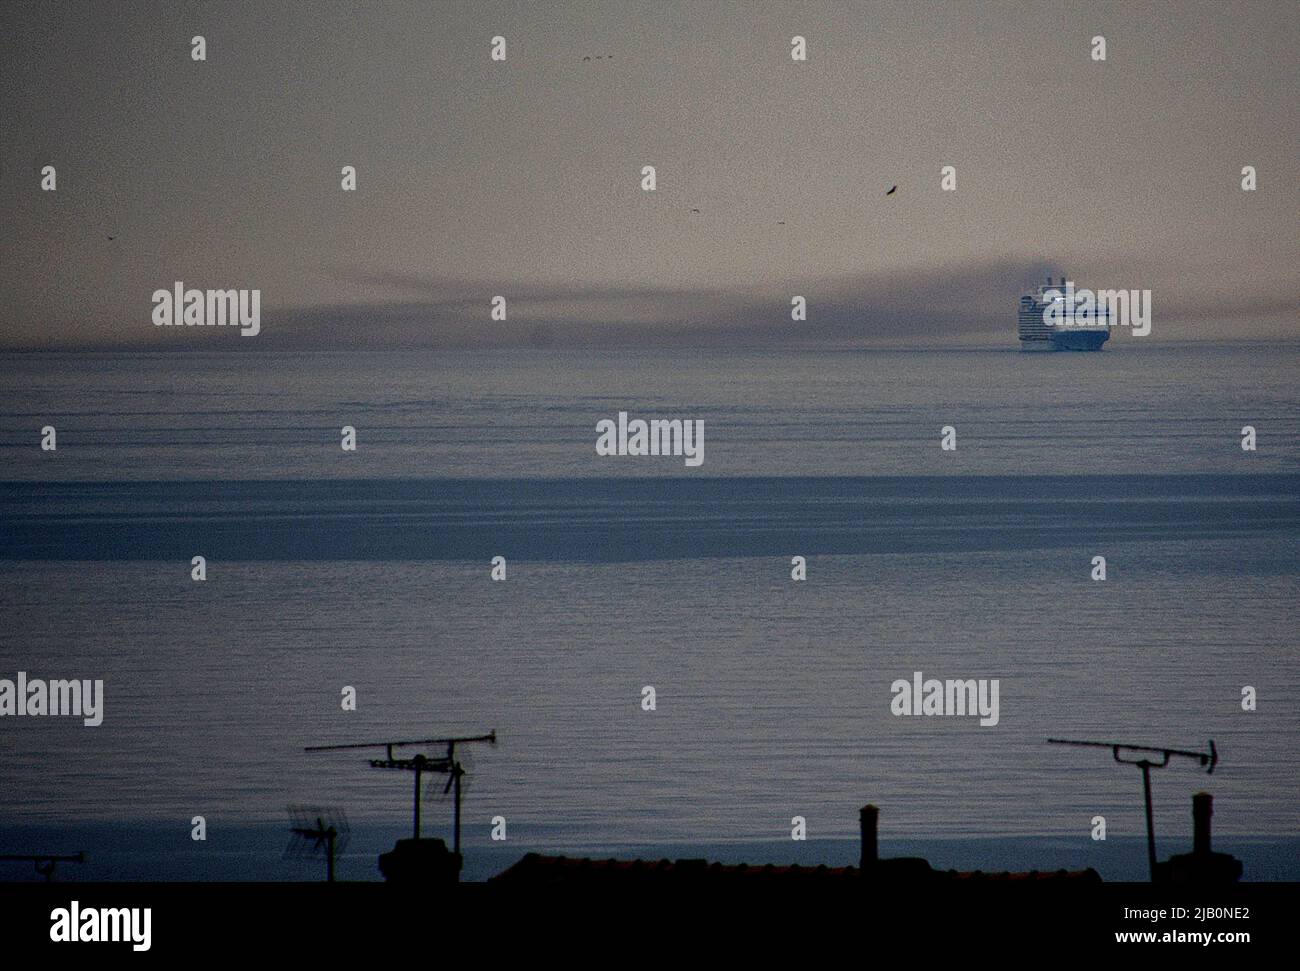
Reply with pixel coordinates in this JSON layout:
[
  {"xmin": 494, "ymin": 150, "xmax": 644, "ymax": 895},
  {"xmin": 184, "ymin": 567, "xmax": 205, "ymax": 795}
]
[{"xmin": 0, "ymin": 342, "xmax": 1300, "ymax": 876}]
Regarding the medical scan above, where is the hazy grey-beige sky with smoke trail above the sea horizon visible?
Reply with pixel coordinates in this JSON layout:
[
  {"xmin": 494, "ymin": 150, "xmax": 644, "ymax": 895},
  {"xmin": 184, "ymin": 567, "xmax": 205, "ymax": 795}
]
[{"xmin": 0, "ymin": 0, "xmax": 1300, "ymax": 350}]
